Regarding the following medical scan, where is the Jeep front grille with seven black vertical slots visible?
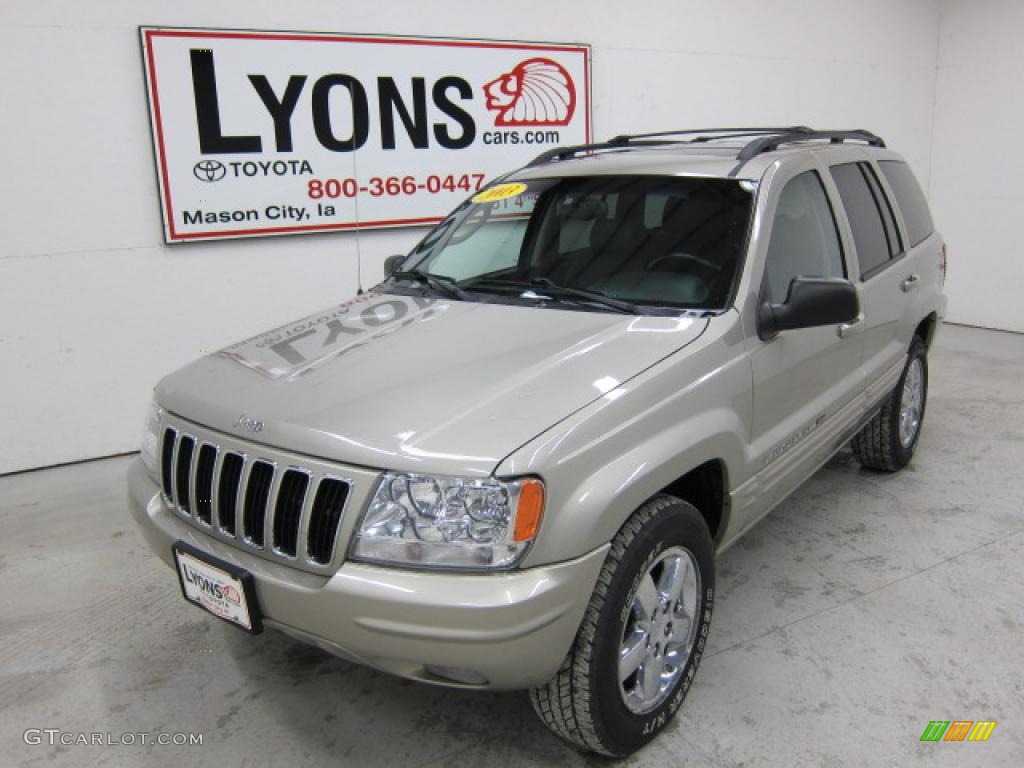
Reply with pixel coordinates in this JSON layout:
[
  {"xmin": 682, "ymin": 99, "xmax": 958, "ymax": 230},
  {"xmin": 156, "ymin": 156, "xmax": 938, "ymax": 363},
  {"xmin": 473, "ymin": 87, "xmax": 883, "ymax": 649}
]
[{"xmin": 161, "ymin": 427, "xmax": 351, "ymax": 566}]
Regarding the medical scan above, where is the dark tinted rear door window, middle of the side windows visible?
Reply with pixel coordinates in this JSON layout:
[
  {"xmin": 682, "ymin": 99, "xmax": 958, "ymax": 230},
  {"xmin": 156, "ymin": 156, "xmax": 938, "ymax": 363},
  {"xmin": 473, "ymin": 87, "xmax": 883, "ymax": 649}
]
[{"xmin": 829, "ymin": 163, "xmax": 900, "ymax": 280}]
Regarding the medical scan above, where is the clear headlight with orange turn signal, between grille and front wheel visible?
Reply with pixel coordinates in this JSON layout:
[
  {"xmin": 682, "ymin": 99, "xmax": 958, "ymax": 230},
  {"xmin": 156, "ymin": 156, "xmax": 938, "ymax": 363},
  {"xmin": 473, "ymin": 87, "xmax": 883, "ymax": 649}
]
[{"xmin": 351, "ymin": 472, "xmax": 544, "ymax": 569}]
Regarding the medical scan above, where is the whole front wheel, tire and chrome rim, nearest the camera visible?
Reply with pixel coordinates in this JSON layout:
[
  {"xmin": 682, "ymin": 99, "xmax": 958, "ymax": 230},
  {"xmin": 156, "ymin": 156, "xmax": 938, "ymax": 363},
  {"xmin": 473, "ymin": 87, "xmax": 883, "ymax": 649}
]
[{"xmin": 530, "ymin": 496, "xmax": 715, "ymax": 757}]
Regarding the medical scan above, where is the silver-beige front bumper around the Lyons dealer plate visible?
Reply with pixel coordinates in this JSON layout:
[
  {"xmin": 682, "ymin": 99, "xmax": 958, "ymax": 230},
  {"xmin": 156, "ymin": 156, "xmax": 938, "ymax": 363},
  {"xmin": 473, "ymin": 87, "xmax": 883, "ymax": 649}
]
[{"xmin": 128, "ymin": 460, "xmax": 608, "ymax": 690}]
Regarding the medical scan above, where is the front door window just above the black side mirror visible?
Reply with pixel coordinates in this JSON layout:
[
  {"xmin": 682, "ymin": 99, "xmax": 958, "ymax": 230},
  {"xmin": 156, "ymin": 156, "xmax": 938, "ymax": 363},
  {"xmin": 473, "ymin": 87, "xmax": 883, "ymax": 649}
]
[{"xmin": 765, "ymin": 171, "xmax": 846, "ymax": 303}]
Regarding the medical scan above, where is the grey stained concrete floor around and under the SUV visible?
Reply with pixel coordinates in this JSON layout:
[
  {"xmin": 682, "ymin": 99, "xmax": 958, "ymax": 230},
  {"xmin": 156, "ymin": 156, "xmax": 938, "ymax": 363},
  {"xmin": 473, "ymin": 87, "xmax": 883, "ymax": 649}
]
[{"xmin": 0, "ymin": 327, "xmax": 1024, "ymax": 768}]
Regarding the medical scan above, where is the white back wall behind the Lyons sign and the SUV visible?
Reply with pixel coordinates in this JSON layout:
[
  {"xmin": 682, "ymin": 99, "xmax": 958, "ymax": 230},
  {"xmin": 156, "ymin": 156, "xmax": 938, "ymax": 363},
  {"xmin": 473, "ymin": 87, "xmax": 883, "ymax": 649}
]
[{"xmin": 0, "ymin": 0, "xmax": 942, "ymax": 473}]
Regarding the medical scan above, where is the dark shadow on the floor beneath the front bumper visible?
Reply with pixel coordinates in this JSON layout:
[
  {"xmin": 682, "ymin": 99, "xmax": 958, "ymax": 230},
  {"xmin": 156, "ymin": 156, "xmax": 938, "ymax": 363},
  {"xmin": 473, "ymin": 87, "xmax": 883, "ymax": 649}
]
[{"xmin": 219, "ymin": 626, "xmax": 604, "ymax": 768}]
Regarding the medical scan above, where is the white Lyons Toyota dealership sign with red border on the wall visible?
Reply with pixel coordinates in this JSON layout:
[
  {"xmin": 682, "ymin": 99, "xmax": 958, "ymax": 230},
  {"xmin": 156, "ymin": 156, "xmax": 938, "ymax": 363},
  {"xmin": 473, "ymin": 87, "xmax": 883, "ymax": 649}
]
[{"xmin": 140, "ymin": 28, "xmax": 591, "ymax": 243}]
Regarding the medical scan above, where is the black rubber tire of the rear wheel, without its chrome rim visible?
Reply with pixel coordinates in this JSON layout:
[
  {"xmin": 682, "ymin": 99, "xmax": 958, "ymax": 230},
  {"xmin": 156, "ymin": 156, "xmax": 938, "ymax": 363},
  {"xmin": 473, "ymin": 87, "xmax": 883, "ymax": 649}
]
[{"xmin": 850, "ymin": 336, "xmax": 928, "ymax": 472}]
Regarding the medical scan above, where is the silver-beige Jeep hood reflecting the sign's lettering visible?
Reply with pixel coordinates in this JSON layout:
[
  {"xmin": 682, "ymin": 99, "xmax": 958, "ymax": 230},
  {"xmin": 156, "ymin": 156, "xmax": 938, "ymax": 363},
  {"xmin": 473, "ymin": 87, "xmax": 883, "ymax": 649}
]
[{"xmin": 157, "ymin": 293, "xmax": 708, "ymax": 475}]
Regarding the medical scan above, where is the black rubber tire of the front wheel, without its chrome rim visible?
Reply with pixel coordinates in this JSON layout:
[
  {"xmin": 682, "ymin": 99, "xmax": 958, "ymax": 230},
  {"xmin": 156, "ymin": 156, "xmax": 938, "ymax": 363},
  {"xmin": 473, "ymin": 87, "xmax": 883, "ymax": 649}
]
[{"xmin": 529, "ymin": 496, "xmax": 715, "ymax": 757}]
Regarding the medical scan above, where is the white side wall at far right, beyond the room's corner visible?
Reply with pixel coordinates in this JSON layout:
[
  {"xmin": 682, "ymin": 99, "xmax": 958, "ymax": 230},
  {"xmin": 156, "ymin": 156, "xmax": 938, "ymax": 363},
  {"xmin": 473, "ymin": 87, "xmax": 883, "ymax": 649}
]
[{"xmin": 930, "ymin": 0, "xmax": 1024, "ymax": 332}]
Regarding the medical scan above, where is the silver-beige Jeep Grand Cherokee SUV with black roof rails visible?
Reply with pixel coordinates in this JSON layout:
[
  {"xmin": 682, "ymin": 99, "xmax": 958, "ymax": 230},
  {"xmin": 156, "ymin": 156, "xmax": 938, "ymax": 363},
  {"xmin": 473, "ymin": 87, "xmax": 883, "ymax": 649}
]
[{"xmin": 129, "ymin": 127, "xmax": 945, "ymax": 756}]
